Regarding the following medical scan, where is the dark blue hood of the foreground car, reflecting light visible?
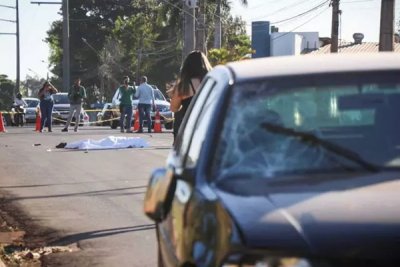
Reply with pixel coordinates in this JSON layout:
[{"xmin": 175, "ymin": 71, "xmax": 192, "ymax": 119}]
[{"xmin": 216, "ymin": 172, "xmax": 400, "ymax": 257}]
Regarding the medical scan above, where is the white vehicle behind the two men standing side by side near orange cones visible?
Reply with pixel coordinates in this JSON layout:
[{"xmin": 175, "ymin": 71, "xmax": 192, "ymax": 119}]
[{"xmin": 107, "ymin": 85, "xmax": 173, "ymax": 129}]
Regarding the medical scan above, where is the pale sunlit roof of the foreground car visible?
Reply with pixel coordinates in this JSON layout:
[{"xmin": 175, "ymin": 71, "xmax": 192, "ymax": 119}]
[{"xmin": 227, "ymin": 52, "xmax": 400, "ymax": 82}]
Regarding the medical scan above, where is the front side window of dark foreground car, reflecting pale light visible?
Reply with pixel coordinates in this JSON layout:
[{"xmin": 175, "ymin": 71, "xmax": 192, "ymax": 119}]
[{"xmin": 186, "ymin": 84, "xmax": 218, "ymax": 167}]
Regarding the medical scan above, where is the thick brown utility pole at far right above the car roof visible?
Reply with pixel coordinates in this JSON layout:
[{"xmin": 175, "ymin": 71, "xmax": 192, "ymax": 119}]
[{"xmin": 379, "ymin": 0, "xmax": 394, "ymax": 51}]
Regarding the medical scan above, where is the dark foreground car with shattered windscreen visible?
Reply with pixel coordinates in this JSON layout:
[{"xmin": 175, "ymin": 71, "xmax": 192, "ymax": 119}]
[{"xmin": 144, "ymin": 53, "xmax": 400, "ymax": 267}]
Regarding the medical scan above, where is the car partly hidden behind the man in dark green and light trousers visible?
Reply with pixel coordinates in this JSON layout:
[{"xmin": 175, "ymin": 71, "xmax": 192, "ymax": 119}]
[{"xmin": 53, "ymin": 93, "xmax": 89, "ymax": 126}]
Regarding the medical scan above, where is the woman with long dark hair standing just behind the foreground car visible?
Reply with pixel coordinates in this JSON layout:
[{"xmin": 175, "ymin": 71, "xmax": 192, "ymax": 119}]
[{"xmin": 168, "ymin": 50, "xmax": 211, "ymax": 140}]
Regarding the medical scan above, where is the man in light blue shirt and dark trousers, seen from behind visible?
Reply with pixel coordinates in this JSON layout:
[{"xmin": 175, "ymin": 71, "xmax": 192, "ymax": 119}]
[{"xmin": 135, "ymin": 76, "xmax": 156, "ymax": 133}]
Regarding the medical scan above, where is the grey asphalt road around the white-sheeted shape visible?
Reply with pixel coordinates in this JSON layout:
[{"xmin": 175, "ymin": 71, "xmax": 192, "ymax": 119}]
[{"xmin": 0, "ymin": 126, "xmax": 172, "ymax": 266}]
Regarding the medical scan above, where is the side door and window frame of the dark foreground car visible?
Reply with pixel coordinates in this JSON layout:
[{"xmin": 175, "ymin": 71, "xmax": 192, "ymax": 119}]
[{"xmin": 160, "ymin": 70, "xmax": 227, "ymax": 266}]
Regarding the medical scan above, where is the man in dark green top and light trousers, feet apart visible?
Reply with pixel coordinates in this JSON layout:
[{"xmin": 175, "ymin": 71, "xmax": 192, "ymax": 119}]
[{"xmin": 61, "ymin": 77, "xmax": 86, "ymax": 132}]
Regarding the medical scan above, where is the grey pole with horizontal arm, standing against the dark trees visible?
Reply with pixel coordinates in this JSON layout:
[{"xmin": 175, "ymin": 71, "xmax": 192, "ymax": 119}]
[{"xmin": 31, "ymin": 0, "xmax": 71, "ymax": 91}]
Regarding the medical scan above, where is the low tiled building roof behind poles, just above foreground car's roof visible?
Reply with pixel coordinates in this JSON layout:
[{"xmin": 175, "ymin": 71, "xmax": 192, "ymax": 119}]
[{"xmin": 308, "ymin": 42, "xmax": 400, "ymax": 55}]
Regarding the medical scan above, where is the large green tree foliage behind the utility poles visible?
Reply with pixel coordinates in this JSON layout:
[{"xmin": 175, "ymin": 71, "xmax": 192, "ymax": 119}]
[{"xmin": 46, "ymin": 0, "xmax": 248, "ymax": 101}]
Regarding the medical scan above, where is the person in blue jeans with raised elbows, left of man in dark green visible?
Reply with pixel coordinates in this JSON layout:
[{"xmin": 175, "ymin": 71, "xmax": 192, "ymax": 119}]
[{"xmin": 38, "ymin": 81, "xmax": 58, "ymax": 132}]
